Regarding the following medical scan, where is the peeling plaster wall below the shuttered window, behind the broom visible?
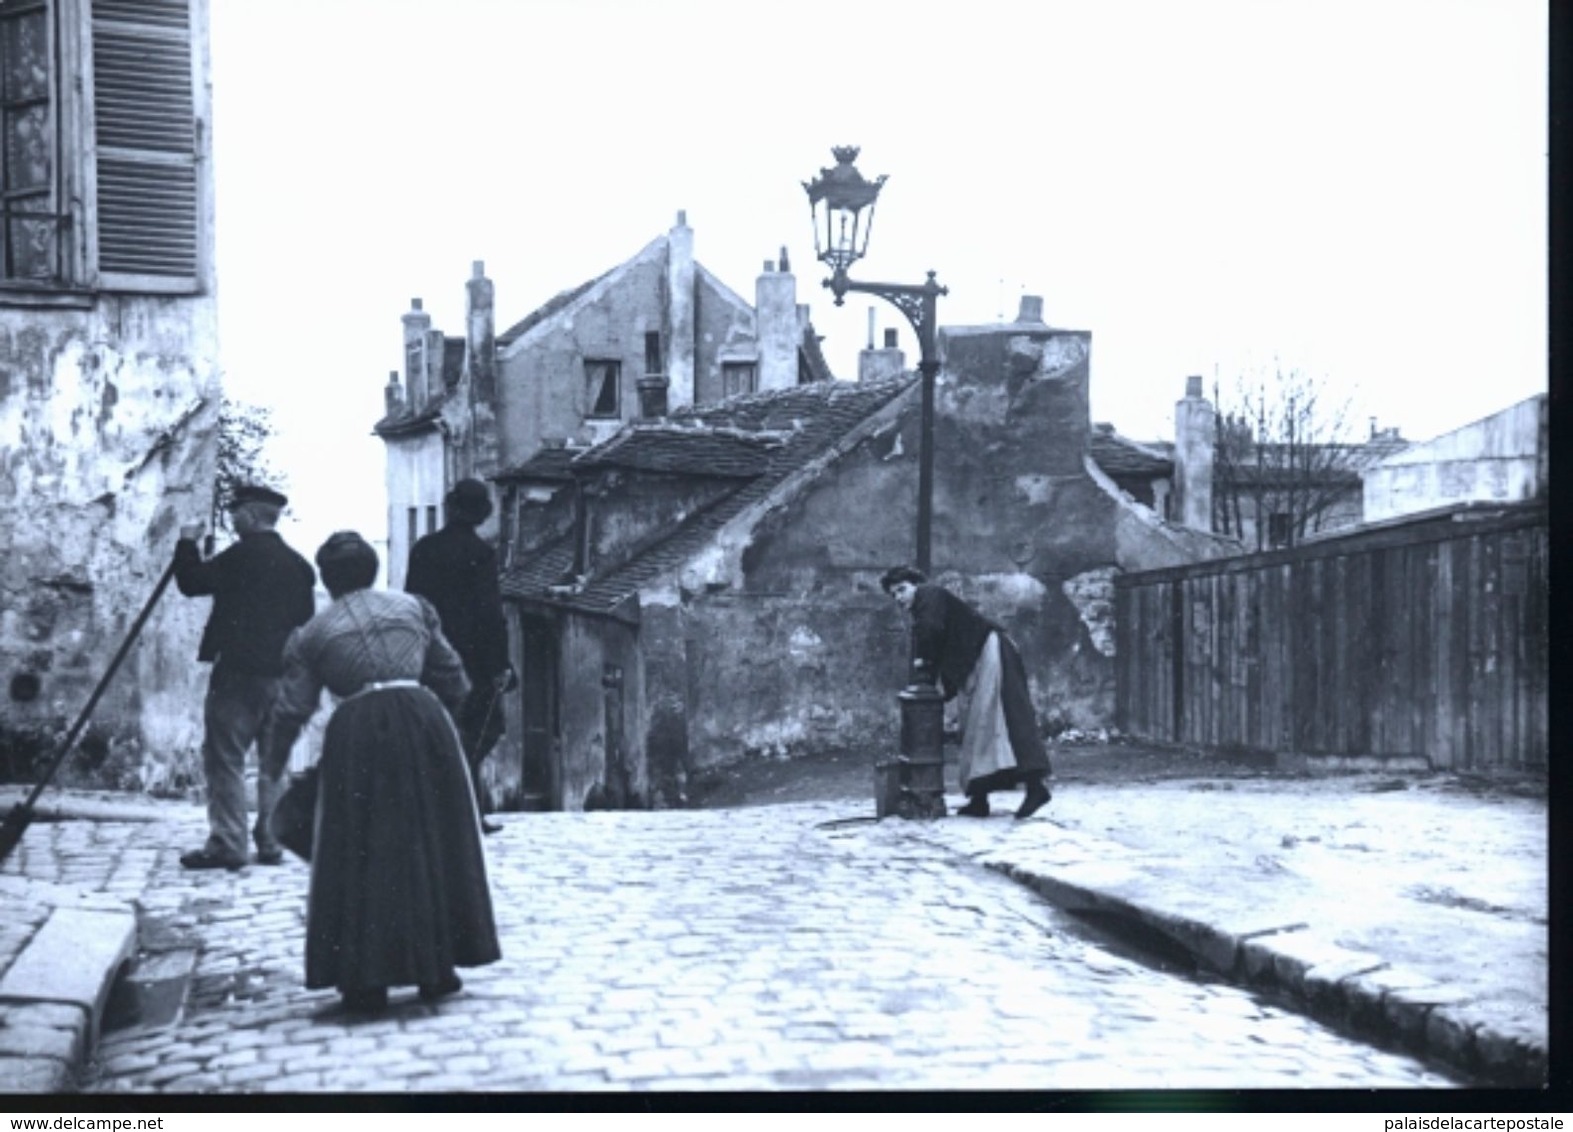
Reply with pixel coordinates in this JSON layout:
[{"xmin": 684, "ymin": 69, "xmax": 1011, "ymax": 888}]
[{"xmin": 0, "ymin": 297, "xmax": 220, "ymax": 789}]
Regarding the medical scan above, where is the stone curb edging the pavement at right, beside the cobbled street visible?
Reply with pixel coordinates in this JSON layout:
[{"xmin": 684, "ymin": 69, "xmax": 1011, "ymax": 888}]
[{"xmin": 982, "ymin": 843, "xmax": 1548, "ymax": 1088}]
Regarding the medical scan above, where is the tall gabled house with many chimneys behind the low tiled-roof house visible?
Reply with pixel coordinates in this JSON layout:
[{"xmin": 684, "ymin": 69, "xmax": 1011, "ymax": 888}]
[{"xmin": 376, "ymin": 212, "xmax": 831, "ymax": 586}]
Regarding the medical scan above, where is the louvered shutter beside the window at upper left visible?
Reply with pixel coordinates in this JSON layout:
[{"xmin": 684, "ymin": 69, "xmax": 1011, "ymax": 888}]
[{"xmin": 93, "ymin": 0, "xmax": 201, "ymax": 291}]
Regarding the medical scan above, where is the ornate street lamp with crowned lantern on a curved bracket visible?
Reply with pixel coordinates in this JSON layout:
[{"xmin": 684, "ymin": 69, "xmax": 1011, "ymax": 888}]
[{"xmin": 802, "ymin": 146, "xmax": 949, "ymax": 818}]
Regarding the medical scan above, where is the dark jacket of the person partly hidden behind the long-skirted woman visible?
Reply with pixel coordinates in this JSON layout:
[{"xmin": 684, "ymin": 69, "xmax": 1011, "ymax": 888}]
[{"xmin": 404, "ymin": 522, "xmax": 508, "ymax": 689}]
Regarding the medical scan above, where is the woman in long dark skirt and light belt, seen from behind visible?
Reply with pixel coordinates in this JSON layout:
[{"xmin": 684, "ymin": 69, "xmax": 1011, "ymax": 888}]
[{"xmin": 261, "ymin": 531, "xmax": 502, "ymax": 1011}]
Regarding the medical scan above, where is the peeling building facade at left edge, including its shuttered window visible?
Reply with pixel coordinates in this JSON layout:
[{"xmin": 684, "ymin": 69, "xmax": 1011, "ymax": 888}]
[{"xmin": 0, "ymin": 0, "xmax": 220, "ymax": 789}]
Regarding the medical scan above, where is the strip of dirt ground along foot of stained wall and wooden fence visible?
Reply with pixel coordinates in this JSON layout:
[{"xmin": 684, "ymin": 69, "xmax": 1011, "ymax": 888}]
[{"xmin": 687, "ymin": 741, "xmax": 1546, "ymax": 810}]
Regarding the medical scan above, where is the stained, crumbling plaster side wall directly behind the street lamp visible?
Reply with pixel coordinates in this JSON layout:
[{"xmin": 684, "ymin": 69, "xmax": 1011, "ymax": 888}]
[{"xmin": 654, "ymin": 324, "xmax": 1230, "ymax": 766}]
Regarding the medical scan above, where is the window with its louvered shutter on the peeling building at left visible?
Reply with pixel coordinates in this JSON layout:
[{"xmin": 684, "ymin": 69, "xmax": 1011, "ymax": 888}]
[{"xmin": 0, "ymin": 0, "xmax": 206, "ymax": 292}]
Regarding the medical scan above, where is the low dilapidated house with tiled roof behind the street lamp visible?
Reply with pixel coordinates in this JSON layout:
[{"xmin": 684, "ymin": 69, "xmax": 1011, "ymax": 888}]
[{"xmin": 494, "ymin": 300, "xmax": 1238, "ymax": 810}]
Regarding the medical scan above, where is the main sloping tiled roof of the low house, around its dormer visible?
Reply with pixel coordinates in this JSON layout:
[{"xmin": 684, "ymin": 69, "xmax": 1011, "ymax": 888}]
[{"xmin": 502, "ymin": 376, "xmax": 915, "ymax": 613}]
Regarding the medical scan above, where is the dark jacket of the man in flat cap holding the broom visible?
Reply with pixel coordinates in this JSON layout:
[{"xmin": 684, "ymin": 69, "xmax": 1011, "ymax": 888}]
[{"xmin": 175, "ymin": 531, "xmax": 316, "ymax": 676}]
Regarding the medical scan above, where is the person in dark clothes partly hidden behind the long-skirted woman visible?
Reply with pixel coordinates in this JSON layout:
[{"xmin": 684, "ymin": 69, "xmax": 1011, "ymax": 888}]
[{"xmin": 404, "ymin": 480, "xmax": 518, "ymax": 833}]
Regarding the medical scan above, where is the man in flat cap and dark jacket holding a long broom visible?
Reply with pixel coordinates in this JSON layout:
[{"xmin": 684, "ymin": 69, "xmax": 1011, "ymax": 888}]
[{"xmin": 175, "ymin": 484, "xmax": 316, "ymax": 871}]
